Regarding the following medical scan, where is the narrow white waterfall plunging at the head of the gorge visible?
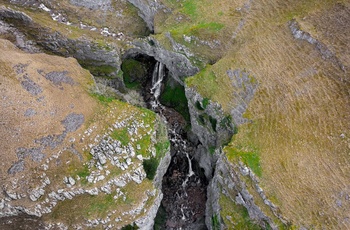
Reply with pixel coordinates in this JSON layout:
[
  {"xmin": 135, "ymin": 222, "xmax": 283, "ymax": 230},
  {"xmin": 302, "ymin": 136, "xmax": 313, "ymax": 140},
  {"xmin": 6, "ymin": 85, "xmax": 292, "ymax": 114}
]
[{"xmin": 151, "ymin": 62, "xmax": 165, "ymax": 109}]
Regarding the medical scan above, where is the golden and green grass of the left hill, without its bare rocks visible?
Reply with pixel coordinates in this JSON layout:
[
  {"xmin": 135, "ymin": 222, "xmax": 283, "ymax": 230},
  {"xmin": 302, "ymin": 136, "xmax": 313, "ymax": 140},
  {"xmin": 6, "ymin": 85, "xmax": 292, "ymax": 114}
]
[{"xmin": 0, "ymin": 39, "xmax": 169, "ymax": 227}]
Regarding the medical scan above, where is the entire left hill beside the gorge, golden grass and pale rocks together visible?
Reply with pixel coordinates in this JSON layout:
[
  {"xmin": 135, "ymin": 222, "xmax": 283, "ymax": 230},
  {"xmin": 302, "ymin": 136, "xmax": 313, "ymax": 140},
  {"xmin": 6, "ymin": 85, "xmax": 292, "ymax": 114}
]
[{"xmin": 0, "ymin": 40, "xmax": 170, "ymax": 229}]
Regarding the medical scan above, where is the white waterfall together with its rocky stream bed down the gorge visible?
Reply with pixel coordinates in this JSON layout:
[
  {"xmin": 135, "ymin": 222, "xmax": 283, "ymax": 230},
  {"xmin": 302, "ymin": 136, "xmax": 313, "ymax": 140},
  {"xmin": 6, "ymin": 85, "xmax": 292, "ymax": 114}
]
[{"xmin": 150, "ymin": 62, "xmax": 207, "ymax": 229}]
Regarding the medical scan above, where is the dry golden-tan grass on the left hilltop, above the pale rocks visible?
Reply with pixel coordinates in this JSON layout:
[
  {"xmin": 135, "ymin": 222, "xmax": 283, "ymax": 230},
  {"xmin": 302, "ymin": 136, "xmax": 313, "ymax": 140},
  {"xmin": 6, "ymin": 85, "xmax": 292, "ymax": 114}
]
[{"xmin": 0, "ymin": 40, "xmax": 97, "ymax": 205}]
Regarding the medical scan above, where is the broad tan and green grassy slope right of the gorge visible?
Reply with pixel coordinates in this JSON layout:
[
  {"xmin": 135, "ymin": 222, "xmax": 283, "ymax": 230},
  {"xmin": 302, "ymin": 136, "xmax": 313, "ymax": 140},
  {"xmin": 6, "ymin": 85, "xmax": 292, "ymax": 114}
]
[{"xmin": 159, "ymin": 0, "xmax": 350, "ymax": 228}]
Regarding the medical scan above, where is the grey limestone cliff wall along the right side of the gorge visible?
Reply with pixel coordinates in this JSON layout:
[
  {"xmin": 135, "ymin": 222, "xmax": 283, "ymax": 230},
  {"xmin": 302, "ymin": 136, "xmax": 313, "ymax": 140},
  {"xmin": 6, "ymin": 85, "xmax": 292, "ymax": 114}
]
[{"xmin": 185, "ymin": 74, "xmax": 287, "ymax": 229}]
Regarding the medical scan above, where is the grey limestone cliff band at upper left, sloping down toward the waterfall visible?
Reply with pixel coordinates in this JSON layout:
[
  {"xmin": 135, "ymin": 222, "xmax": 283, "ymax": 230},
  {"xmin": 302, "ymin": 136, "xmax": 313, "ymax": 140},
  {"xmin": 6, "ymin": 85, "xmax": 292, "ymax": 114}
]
[{"xmin": 0, "ymin": 7, "xmax": 121, "ymax": 77}]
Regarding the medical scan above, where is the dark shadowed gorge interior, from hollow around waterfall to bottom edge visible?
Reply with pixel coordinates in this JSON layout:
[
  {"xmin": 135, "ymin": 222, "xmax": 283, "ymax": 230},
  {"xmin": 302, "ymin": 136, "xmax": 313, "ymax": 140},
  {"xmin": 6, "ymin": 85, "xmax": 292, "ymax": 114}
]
[{"xmin": 122, "ymin": 54, "xmax": 208, "ymax": 229}]
